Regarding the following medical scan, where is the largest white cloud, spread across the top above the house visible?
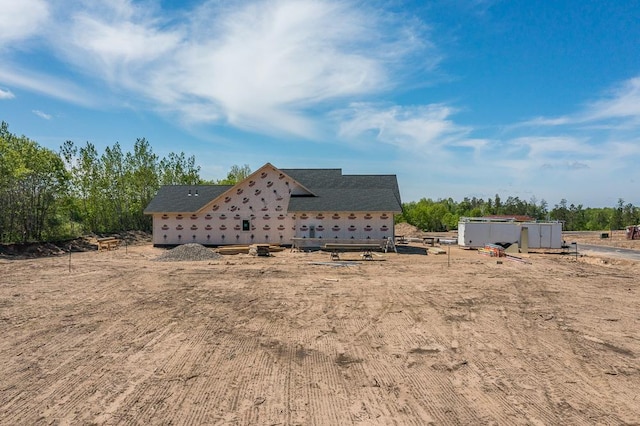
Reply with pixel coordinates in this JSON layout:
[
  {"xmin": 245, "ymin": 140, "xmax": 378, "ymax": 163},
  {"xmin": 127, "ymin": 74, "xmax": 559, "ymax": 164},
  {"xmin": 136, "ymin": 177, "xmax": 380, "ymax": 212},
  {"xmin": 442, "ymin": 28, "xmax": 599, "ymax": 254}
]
[{"xmin": 36, "ymin": 0, "xmax": 439, "ymax": 137}]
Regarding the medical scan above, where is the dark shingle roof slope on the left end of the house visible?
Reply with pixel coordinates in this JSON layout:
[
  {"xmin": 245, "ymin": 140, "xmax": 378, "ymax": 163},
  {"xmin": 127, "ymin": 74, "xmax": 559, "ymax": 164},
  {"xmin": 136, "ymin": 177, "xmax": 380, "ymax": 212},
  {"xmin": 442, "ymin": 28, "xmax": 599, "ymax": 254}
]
[{"xmin": 144, "ymin": 185, "xmax": 233, "ymax": 214}]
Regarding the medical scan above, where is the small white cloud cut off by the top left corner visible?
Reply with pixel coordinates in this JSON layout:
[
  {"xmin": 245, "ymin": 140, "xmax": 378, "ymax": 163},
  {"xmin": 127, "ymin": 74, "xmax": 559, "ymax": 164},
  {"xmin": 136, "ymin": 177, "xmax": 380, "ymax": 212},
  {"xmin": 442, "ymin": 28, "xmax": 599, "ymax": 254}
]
[{"xmin": 0, "ymin": 0, "xmax": 49, "ymax": 48}]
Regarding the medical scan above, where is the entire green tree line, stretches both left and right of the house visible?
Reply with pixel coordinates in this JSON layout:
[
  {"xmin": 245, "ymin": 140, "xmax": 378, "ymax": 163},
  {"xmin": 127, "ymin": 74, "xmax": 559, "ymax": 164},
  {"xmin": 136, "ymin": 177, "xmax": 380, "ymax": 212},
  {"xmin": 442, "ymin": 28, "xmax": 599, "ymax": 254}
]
[{"xmin": 0, "ymin": 122, "xmax": 640, "ymax": 243}]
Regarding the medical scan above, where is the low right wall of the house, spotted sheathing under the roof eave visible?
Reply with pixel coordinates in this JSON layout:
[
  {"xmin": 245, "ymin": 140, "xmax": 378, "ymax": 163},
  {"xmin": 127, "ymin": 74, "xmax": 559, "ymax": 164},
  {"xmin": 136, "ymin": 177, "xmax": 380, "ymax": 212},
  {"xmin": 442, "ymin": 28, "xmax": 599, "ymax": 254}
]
[{"xmin": 293, "ymin": 212, "xmax": 394, "ymax": 240}]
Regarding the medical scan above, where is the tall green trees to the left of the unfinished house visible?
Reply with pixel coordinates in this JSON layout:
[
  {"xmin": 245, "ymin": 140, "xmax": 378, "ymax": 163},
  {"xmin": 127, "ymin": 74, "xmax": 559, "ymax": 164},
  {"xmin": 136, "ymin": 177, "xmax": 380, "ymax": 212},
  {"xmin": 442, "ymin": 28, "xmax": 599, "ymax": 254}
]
[{"xmin": 0, "ymin": 122, "xmax": 251, "ymax": 243}]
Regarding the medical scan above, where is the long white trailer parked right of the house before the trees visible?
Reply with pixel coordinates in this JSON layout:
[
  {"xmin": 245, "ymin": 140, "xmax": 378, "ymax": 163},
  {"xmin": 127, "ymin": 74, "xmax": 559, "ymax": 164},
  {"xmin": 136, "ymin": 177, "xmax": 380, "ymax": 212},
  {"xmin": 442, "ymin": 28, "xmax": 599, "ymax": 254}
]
[{"xmin": 458, "ymin": 218, "xmax": 562, "ymax": 249}]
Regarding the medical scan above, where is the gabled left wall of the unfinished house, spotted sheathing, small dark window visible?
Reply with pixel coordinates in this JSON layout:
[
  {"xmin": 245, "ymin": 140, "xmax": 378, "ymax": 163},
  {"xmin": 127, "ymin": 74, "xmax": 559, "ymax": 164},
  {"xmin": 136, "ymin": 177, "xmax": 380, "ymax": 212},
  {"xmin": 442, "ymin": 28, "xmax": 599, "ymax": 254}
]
[{"xmin": 153, "ymin": 168, "xmax": 295, "ymax": 245}]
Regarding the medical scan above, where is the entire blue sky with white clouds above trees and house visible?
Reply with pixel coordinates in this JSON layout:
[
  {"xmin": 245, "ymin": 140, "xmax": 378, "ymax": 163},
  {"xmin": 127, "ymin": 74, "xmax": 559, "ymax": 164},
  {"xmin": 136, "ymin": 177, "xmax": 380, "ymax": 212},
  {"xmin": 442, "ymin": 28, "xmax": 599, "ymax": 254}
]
[{"xmin": 0, "ymin": 0, "xmax": 640, "ymax": 207}]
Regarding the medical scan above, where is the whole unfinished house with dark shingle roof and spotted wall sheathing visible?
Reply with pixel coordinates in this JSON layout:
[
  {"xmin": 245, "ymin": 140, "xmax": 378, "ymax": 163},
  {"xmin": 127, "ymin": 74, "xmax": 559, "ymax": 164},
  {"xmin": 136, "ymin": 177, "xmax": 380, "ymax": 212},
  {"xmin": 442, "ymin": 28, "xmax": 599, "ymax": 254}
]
[{"xmin": 144, "ymin": 163, "xmax": 402, "ymax": 246}]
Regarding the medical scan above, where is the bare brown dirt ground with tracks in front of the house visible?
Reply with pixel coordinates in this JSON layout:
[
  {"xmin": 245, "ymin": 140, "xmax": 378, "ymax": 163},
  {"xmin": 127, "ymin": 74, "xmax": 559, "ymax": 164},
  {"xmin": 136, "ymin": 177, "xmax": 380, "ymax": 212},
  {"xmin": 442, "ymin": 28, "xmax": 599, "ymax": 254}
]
[{"xmin": 0, "ymin": 234, "xmax": 640, "ymax": 425}]
